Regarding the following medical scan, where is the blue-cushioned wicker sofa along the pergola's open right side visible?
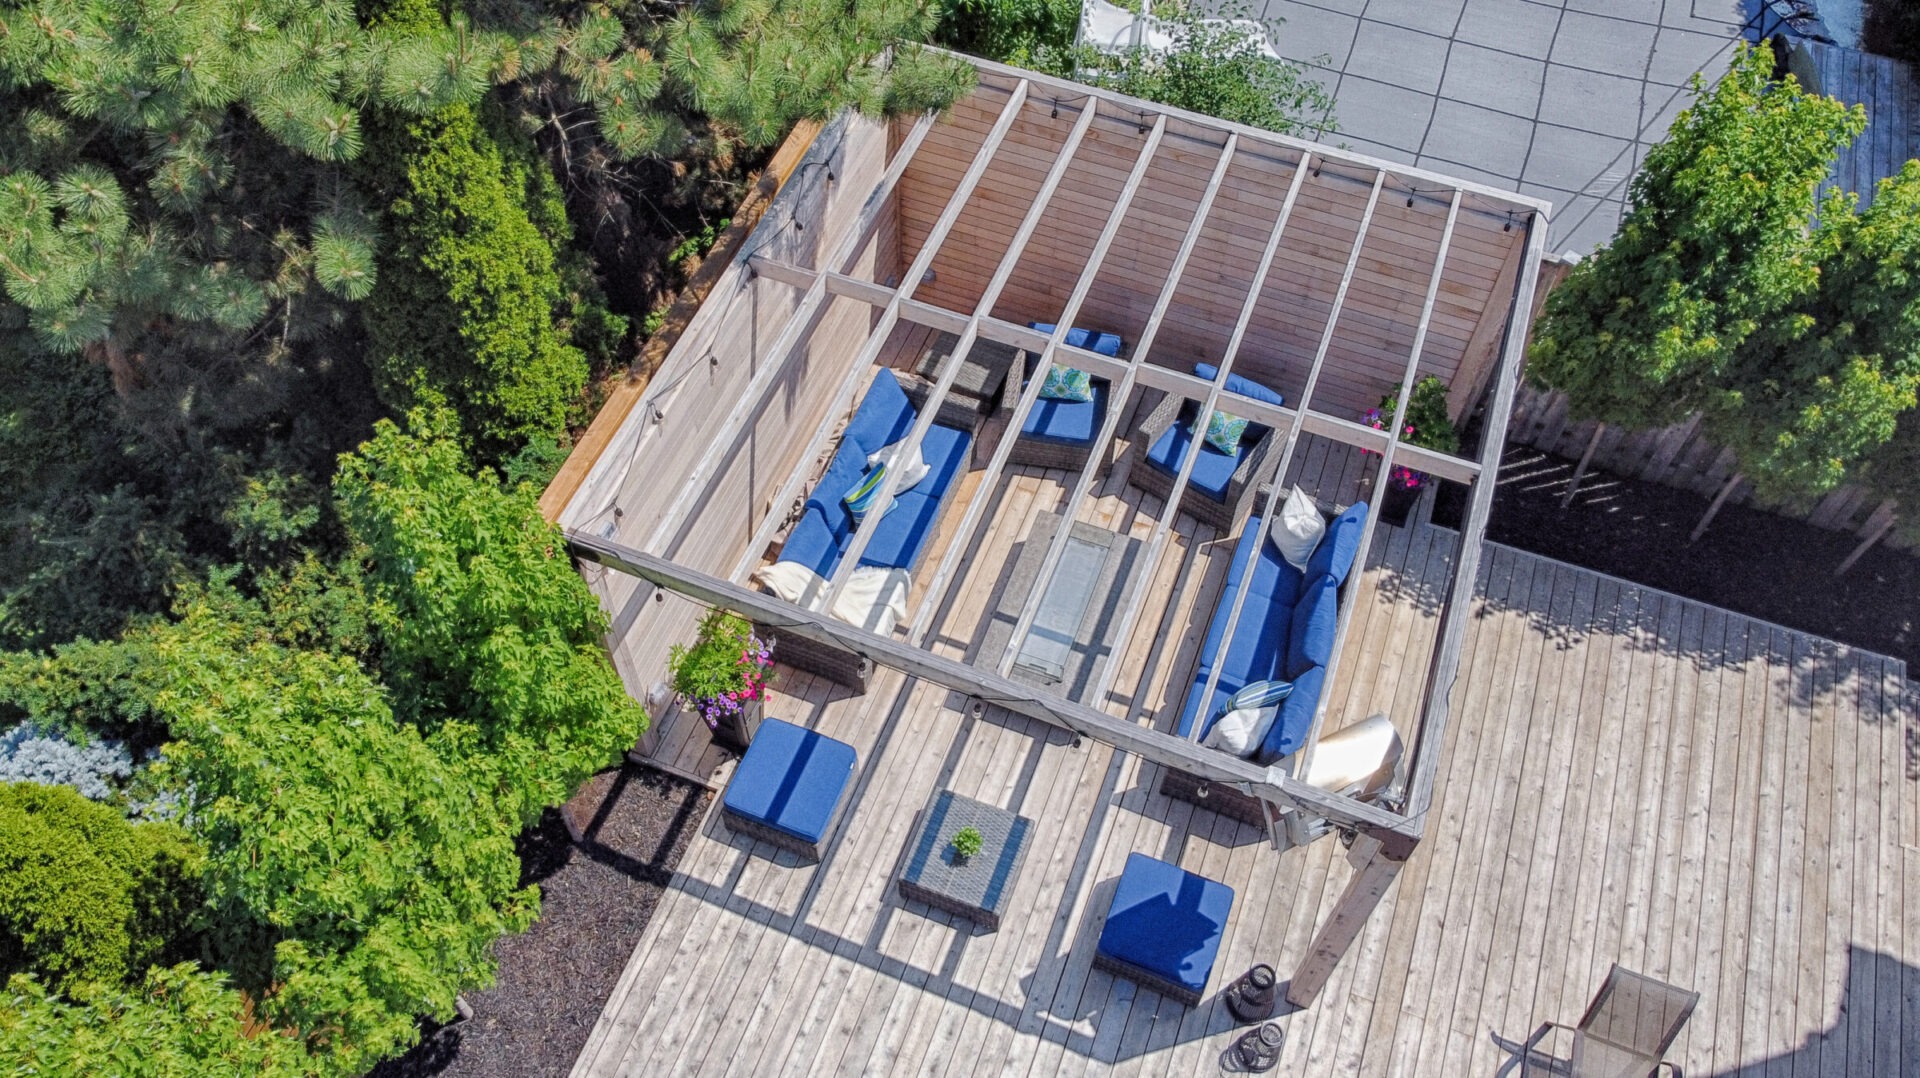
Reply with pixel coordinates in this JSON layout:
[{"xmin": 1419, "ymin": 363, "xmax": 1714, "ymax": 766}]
[{"xmin": 1160, "ymin": 502, "xmax": 1367, "ymax": 826}]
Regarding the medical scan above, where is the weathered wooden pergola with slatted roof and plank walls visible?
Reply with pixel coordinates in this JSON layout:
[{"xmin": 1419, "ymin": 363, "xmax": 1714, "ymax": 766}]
[{"xmin": 561, "ymin": 61, "xmax": 1549, "ymax": 1005}]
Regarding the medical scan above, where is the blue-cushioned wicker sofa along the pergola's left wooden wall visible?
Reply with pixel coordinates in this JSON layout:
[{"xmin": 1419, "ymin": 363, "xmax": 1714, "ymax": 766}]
[{"xmin": 756, "ymin": 367, "xmax": 973, "ymax": 692}]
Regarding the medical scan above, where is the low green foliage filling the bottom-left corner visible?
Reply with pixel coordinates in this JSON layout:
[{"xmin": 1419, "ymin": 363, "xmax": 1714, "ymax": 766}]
[{"xmin": 0, "ymin": 963, "xmax": 326, "ymax": 1078}]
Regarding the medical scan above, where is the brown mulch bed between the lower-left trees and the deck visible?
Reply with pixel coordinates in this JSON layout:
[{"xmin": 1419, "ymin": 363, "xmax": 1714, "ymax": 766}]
[{"xmin": 372, "ymin": 765, "xmax": 708, "ymax": 1078}]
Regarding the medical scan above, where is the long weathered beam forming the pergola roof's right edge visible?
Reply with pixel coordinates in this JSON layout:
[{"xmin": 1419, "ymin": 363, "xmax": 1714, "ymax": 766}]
[{"xmin": 1405, "ymin": 215, "xmax": 1548, "ymax": 830}]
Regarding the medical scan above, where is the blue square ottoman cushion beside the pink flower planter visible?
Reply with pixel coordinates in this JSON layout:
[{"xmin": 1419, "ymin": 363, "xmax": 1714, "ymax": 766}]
[{"xmin": 722, "ymin": 719, "xmax": 854, "ymax": 844}]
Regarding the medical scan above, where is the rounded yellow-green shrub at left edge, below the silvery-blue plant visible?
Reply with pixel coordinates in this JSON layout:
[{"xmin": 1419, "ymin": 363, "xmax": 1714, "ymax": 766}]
[{"xmin": 0, "ymin": 782, "xmax": 200, "ymax": 995}]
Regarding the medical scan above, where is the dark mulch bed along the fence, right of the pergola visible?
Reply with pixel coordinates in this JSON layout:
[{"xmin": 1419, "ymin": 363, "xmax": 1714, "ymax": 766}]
[{"xmin": 1486, "ymin": 446, "xmax": 1920, "ymax": 669}]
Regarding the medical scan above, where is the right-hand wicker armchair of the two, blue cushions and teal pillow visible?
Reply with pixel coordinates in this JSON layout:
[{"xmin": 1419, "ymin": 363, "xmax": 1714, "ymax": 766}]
[{"xmin": 1129, "ymin": 363, "xmax": 1284, "ymax": 532}]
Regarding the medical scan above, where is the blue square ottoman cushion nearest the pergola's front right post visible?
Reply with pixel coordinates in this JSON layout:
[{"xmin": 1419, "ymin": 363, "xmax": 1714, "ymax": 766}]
[{"xmin": 1098, "ymin": 853, "xmax": 1233, "ymax": 992}]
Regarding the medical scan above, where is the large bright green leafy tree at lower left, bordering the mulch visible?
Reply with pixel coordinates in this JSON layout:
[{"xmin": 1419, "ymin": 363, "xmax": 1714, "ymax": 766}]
[{"xmin": 152, "ymin": 601, "xmax": 538, "ymax": 1074}]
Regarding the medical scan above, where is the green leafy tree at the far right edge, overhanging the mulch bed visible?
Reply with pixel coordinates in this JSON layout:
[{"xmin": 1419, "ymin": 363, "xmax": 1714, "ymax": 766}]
[{"xmin": 1703, "ymin": 161, "xmax": 1920, "ymax": 498}]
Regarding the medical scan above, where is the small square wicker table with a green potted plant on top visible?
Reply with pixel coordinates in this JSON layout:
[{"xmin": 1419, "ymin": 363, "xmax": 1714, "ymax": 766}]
[{"xmin": 900, "ymin": 790, "xmax": 1033, "ymax": 930}]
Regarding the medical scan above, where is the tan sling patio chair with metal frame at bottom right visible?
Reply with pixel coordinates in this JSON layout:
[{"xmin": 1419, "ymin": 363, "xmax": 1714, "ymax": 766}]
[{"xmin": 1521, "ymin": 963, "xmax": 1699, "ymax": 1078}]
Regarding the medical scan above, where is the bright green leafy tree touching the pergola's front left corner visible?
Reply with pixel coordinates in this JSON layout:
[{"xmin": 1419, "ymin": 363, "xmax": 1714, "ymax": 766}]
[{"xmin": 334, "ymin": 413, "xmax": 647, "ymax": 824}]
